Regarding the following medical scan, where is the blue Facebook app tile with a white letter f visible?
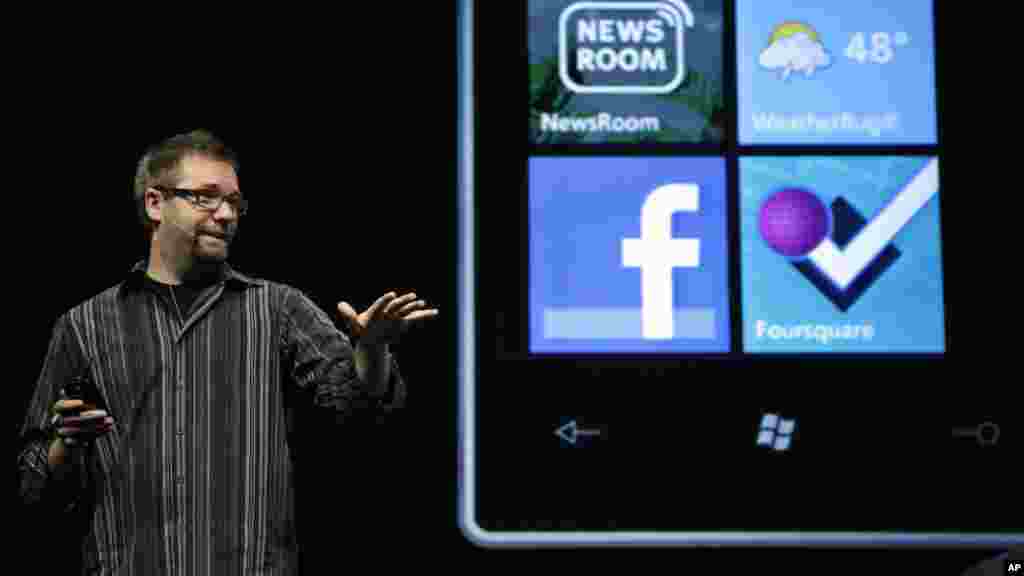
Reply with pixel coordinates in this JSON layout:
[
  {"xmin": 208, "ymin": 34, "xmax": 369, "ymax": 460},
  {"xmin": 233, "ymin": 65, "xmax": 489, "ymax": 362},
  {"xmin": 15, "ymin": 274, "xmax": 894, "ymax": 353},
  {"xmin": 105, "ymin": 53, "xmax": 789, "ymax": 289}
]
[{"xmin": 529, "ymin": 158, "xmax": 730, "ymax": 354}]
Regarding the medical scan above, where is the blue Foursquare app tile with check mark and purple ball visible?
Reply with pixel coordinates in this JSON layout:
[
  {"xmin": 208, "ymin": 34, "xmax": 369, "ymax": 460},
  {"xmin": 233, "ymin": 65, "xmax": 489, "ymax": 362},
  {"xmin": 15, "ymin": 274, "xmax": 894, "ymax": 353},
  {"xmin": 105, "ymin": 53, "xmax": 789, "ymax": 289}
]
[{"xmin": 739, "ymin": 157, "xmax": 945, "ymax": 354}]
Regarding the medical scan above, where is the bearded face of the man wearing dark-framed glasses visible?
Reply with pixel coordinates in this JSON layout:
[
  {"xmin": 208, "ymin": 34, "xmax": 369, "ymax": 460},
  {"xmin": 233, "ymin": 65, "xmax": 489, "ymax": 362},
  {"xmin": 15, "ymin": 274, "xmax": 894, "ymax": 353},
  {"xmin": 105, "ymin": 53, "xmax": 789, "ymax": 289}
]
[{"xmin": 147, "ymin": 155, "xmax": 240, "ymax": 261}]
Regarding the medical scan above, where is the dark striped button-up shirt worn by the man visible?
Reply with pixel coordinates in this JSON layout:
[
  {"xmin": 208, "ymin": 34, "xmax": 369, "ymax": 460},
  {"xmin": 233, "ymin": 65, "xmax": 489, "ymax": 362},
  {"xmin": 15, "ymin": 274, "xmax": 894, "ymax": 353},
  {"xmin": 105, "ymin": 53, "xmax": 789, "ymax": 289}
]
[{"xmin": 18, "ymin": 261, "xmax": 406, "ymax": 576}]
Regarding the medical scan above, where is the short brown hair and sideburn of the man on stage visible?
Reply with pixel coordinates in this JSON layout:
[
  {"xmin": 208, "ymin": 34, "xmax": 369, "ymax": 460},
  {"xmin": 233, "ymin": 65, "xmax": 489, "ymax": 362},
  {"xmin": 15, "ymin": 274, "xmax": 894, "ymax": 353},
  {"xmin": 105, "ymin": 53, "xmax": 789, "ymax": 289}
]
[{"xmin": 132, "ymin": 129, "xmax": 241, "ymax": 243}]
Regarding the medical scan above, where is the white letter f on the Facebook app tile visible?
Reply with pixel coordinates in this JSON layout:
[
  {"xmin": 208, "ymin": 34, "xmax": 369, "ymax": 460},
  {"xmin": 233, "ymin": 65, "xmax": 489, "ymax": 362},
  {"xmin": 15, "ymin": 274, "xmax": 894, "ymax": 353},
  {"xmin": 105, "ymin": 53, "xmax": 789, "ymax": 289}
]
[{"xmin": 623, "ymin": 183, "xmax": 700, "ymax": 339}]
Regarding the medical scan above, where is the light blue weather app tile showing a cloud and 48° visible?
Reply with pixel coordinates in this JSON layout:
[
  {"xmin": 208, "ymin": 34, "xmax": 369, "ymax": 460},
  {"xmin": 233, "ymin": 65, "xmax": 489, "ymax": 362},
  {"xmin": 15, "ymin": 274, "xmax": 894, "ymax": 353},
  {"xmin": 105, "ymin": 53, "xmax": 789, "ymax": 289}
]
[{"xmin": 736, "ymin": 0, "xmax": 936, "ymax": 145}]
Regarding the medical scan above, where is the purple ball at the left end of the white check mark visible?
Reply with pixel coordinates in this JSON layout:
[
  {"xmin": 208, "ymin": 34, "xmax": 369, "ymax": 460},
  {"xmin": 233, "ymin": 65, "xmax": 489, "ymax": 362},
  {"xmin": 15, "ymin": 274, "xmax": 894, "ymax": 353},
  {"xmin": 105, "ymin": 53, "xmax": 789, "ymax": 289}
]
[{"xmin": 759, "ymin": 188, "xmax": 831, "ymax": 258}]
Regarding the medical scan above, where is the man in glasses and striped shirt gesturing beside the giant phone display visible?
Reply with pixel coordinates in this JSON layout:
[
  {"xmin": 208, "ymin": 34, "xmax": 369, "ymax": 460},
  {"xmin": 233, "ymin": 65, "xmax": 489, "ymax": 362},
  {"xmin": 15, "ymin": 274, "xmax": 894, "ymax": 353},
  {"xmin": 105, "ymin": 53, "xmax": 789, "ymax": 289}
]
[{"xmin": 18, "ymin": 130, "xmax": 438, "ymax": 575}]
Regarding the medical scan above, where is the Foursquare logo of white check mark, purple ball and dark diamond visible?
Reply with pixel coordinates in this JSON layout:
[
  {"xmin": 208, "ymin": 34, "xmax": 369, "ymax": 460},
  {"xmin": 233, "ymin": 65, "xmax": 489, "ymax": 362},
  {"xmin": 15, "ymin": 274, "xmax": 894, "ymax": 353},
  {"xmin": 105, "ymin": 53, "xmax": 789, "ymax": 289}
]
[{"xmin": 758, "ymin": 159, "xmax": 939, "ymax": 312}]
